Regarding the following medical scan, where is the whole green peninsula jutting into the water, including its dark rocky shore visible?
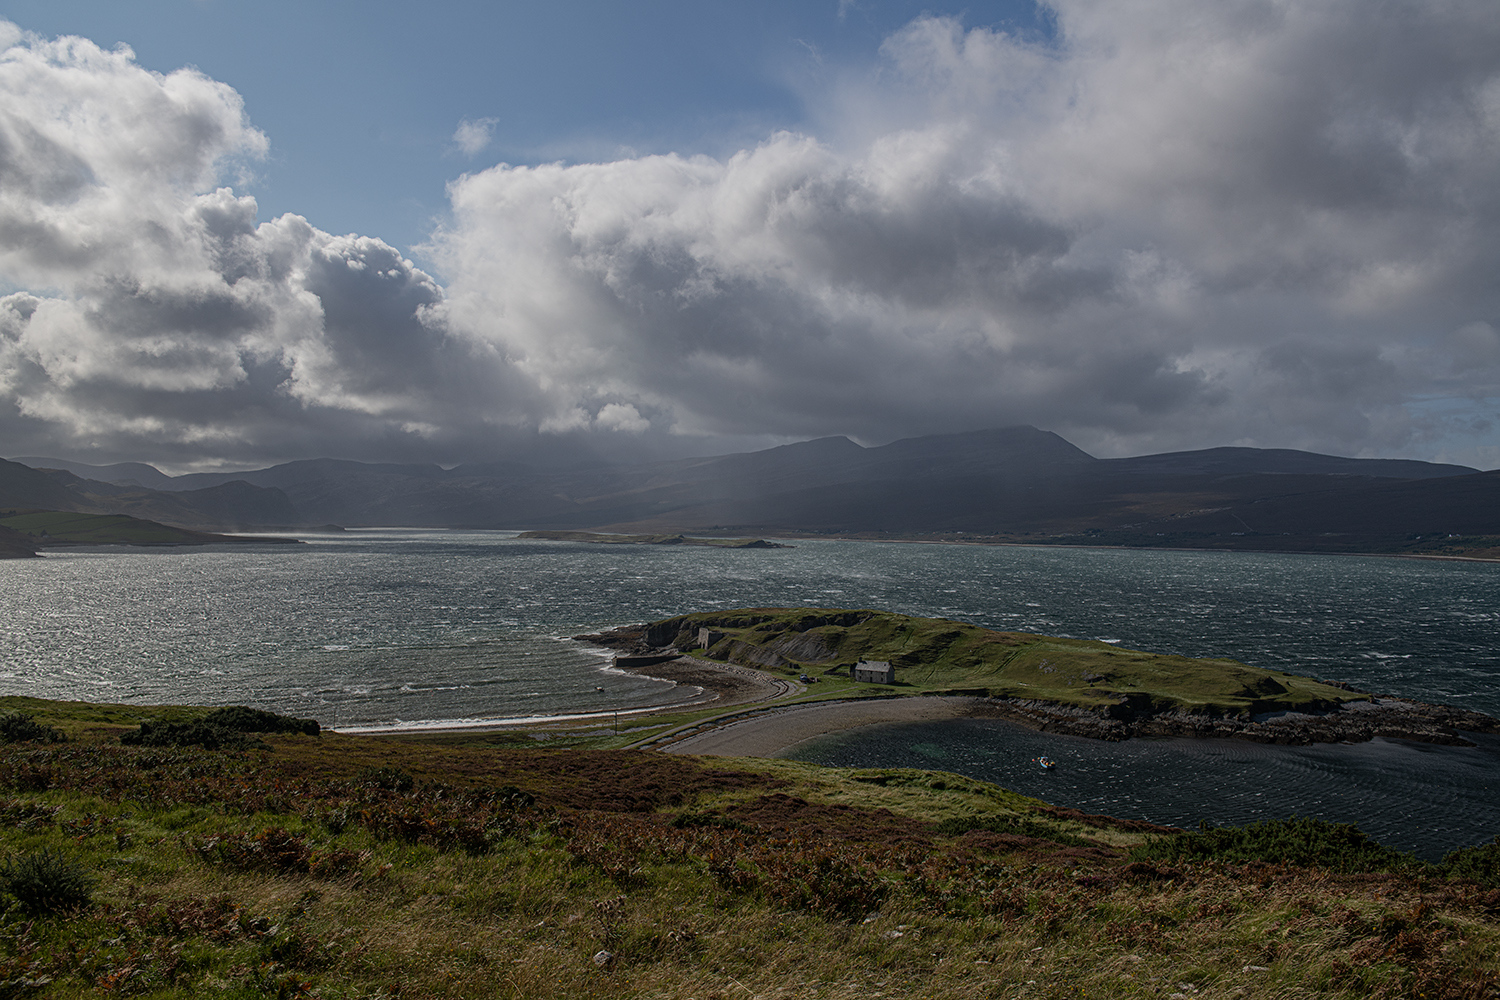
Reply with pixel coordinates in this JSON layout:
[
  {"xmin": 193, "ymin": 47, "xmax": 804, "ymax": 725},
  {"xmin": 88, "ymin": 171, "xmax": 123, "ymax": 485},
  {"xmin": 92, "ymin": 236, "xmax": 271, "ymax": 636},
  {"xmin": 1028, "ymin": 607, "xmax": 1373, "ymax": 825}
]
[{"xmin": 603, "ymin": 607, "xmax": 1500, "ymax": 744}]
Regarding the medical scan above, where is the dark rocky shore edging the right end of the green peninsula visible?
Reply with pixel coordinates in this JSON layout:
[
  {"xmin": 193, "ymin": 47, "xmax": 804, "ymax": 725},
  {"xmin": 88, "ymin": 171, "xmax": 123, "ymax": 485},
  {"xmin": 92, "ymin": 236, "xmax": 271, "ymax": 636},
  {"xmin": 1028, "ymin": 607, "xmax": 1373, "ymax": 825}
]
[{"xmin": 983, "ymin": 694, "xmax": 1500, "ymax": 747}]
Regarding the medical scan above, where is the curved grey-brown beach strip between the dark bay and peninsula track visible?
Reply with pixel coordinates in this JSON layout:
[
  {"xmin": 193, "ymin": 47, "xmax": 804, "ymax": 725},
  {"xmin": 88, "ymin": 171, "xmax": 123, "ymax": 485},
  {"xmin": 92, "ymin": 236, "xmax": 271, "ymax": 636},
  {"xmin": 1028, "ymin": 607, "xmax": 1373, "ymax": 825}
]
[{"xmin": 663, "ymin": 697, "xmax": 983, "ymax": 757}]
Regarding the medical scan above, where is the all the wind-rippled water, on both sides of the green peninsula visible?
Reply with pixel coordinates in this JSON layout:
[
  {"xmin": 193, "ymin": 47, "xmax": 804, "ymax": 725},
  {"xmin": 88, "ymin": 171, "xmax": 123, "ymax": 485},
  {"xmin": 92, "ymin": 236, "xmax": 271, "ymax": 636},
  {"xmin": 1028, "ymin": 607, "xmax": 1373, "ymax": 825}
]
[{"xmin": 0, "ymin": 531, "xmax": 1500, "ymax": 846}]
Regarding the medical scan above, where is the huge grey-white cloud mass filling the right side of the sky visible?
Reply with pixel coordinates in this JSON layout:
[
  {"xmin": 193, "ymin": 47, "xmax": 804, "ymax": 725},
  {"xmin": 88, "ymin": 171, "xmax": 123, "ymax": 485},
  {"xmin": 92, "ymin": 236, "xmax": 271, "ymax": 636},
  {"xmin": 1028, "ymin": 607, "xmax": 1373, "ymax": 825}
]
[{"xmin": 434, "ymin": 0, "xmax": 1500, "ymax": 453}]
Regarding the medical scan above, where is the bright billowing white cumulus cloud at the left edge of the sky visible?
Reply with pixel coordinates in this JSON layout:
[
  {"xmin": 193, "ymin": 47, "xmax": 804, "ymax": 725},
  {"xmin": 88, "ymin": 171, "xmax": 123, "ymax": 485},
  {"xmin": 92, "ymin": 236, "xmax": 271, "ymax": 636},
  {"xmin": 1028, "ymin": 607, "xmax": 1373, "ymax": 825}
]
[{"xmin": 0, "ymin": 25, "xmax": 528, "ymax": 465}]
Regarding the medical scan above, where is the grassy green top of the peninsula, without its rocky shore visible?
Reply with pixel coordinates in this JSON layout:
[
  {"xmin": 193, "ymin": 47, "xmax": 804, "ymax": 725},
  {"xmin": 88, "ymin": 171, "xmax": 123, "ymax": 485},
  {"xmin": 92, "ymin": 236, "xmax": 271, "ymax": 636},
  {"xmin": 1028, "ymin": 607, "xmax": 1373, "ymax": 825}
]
[{"xmin": 656, "ymin": 609, "xmax": 1368, "ymax": 715}]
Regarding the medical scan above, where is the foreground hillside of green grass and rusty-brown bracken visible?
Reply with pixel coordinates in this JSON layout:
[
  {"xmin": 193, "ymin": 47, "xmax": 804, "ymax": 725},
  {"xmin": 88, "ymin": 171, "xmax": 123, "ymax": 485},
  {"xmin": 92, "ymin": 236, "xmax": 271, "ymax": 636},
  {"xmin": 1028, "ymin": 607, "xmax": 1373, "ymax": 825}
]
[{"xmin": 0, "ymin": 703, "xmax": 1500, "ymax": 1000}]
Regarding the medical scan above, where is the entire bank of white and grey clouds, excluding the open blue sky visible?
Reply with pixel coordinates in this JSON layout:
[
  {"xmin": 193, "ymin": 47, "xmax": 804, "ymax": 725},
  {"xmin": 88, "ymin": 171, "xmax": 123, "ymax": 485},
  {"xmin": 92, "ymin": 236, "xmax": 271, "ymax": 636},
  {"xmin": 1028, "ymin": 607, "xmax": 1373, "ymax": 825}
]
[{"xmin": 0, "ymin": 0, "xmax": 1500, "ymax": 468}]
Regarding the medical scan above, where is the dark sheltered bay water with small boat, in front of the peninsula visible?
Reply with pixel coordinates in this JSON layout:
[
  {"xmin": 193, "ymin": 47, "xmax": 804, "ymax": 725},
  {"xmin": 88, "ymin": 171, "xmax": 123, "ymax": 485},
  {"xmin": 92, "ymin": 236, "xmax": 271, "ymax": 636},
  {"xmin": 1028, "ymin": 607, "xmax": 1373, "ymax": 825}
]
[{"xmin": 789, "ymin": 720, "xmax": 1500, "ymax": 861}]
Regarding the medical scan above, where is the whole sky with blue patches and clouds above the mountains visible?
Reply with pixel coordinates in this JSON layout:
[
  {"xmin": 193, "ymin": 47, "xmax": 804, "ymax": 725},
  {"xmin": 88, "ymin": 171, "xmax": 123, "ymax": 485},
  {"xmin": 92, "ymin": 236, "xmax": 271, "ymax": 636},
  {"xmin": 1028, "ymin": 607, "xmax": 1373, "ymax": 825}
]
[{"xmin": 0, "ymin": 0, "xmax": 1500, "ymax": 471}]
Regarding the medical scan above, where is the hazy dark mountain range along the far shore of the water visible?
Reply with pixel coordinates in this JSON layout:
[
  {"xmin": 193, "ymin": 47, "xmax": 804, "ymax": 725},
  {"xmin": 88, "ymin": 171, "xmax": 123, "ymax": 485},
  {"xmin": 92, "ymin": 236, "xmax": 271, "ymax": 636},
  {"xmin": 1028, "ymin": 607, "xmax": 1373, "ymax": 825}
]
[{"xmin": 0, "ymin": 426, "xmax": 1500, "ymax": 553}]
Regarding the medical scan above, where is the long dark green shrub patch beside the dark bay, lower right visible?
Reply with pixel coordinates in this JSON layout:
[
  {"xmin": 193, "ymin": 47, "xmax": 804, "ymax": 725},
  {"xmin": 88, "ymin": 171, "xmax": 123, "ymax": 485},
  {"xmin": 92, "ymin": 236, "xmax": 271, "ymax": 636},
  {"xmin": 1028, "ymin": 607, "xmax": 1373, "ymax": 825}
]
[{"xmin": 1131, "ymin": 816, "xmax": 1424, "ymax": 873}]
